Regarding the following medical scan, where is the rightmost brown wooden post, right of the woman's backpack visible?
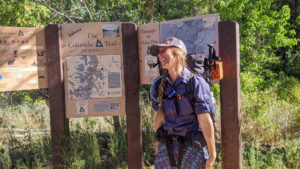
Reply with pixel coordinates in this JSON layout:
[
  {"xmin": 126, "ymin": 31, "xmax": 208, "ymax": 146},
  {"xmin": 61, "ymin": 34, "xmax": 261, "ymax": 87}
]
[{"xmin": 218, "ymin": 21, "xmax": 242, "ymax": 169}]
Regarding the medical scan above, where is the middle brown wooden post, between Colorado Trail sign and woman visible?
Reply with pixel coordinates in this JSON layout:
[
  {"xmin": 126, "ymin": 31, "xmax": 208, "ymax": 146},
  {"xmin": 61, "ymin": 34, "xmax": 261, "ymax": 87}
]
[{"xmin": 122, "ymin": 23, "xmax": 143, "ymax": 169}]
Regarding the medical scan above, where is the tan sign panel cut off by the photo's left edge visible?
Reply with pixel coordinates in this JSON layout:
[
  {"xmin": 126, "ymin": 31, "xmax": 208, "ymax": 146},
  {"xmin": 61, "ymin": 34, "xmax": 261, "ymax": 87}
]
[{"xmin": 0, "ymin": 27, "xmax": 48, "ymax": 92}]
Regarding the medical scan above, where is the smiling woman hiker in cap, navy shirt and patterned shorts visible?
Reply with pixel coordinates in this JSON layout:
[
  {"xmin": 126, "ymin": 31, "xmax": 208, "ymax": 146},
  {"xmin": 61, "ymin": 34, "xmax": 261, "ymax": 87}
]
[{"xmin": 150, "ymin": 37, "xmax": 216, "ymax": 169}]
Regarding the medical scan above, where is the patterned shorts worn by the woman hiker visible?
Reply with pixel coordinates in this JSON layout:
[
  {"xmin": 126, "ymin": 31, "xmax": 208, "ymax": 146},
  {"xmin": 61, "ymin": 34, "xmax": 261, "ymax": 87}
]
[{"xmin": 155, "ymin": 142, "xmax": 209, "ymax": 169}]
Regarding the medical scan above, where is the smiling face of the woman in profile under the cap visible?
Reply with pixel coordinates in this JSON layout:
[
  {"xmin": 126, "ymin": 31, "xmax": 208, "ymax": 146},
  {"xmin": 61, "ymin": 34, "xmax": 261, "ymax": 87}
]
[{"xmin": 157, "ymin": 47, "xmax": 176, "ymax": 70}]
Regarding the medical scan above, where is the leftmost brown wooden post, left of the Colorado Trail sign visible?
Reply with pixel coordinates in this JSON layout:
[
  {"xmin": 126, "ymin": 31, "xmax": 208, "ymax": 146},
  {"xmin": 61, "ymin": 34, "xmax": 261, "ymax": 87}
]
[{"xmin": 45, "ymin": 25, "xmax": 69, "ymax": 168}]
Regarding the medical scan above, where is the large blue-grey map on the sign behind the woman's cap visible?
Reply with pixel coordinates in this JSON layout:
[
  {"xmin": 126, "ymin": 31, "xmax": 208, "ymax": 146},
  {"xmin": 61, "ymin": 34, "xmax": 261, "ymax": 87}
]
[{"xmin": 161, "ymin": 15, "xmax": 217, "ymax": 56}]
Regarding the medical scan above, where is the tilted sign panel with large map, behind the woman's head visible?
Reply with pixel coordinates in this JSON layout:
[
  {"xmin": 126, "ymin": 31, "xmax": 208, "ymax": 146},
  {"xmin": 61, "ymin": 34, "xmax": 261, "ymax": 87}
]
[{"xmin": 138, "ymin": 14, "xmax": 219, "ymax": 84}]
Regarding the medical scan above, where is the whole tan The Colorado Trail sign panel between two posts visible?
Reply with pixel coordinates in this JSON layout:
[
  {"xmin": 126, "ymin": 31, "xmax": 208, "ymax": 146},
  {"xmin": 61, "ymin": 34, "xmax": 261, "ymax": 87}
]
[{"xmin": 61, "ymin": 23, "xmax": 125, "ymax": 118}]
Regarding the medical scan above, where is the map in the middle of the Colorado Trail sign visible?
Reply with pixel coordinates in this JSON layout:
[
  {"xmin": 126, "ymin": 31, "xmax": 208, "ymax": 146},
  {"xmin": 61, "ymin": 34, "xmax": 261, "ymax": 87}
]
[{"xmin": 67, "ymin": 55, "xmax": 122, "ymax": 99}]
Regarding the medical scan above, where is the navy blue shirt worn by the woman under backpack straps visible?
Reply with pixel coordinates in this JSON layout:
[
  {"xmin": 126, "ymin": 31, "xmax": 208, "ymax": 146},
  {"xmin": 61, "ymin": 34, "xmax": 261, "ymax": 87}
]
[{"xmin": 150, "ymin": 68, "xmax": 211, "ymax": 136}]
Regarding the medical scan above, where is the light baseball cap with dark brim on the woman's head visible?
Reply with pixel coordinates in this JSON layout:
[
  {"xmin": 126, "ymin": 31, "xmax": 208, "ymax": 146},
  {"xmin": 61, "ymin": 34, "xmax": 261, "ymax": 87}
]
[{"xmin": 150, "ymin": 37, "xmax": 187, "ymax": 56}]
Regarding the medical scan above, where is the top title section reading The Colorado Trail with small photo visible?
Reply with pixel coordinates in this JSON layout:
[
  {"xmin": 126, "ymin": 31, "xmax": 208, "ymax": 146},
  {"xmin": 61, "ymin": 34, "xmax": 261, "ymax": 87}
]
[{"xmin": 61, "ymin": 23, "xmax": 122, "ymax": 57}]
